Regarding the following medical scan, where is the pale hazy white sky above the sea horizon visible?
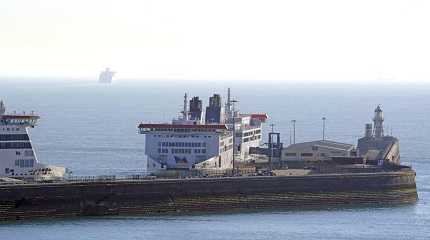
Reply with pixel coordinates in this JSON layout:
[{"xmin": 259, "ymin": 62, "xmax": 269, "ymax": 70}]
[{"xmin": 0, "ymin": 0, "xmax": 430, "ymax": 82}]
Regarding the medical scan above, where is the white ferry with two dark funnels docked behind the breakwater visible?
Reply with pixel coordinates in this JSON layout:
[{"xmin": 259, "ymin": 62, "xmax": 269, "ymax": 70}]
[{"xmin": 138, "ymin": 89, "xmax": 268, "ymax": 173}]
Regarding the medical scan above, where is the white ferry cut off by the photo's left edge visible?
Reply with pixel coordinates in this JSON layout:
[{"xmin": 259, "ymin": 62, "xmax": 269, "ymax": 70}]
[{"xmin": 0, "ymin": 101, "xmax": 66, "ymax": 181}]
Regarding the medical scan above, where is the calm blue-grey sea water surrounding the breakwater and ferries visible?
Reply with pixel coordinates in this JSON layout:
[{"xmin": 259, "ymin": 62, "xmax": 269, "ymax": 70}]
[{"xmin": 0, "ymin": 80, "xmax": 430, "ymax": 240}]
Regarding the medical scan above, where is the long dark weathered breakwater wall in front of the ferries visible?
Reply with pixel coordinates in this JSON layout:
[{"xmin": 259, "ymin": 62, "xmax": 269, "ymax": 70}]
[{"xmin": 0, "ymin": 170, "xmax": 417, "ymax": 220}]
